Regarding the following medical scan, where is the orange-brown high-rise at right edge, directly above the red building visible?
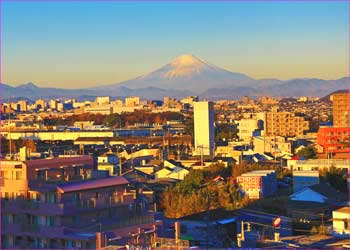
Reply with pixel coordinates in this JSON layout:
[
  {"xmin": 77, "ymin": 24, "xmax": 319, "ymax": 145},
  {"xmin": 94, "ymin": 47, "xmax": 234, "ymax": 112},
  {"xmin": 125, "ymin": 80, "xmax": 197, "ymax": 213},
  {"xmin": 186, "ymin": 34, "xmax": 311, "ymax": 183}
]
[{"xmin": 331, "ymin": 93, "xmax": 350, "ymax": 128}]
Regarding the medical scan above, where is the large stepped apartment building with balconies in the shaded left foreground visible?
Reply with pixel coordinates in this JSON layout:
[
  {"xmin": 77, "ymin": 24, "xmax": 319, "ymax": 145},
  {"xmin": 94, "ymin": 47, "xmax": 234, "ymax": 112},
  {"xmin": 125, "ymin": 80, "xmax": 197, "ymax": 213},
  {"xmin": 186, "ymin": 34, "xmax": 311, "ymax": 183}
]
[{"xmin": 0, "ymin": 150, "xmax": 155, "ymax": 249}]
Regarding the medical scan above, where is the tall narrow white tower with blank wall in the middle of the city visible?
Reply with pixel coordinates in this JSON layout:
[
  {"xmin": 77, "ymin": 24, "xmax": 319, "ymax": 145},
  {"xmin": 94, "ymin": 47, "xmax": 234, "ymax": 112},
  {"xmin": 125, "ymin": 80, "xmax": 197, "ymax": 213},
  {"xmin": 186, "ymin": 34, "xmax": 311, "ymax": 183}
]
[{"xmin": 193, "ymin": 102, "xmax": 215, "ymax": 156}]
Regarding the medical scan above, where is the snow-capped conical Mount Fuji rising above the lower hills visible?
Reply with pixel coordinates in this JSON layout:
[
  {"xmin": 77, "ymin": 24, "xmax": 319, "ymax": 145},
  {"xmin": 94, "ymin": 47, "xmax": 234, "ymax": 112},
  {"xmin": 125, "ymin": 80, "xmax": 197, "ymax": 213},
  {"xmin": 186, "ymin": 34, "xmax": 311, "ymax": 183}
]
[{"xmin": 94, "ymin": 54, "xmax": 254, "ymax": 94}]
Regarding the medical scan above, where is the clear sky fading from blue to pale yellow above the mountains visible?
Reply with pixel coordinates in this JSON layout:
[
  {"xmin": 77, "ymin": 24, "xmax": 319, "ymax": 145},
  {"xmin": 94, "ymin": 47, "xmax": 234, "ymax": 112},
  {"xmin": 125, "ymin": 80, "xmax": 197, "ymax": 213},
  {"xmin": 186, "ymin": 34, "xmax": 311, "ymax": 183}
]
[{"xmin": 1, "ymin": 1, "xmax": 349, "ymax": 88}]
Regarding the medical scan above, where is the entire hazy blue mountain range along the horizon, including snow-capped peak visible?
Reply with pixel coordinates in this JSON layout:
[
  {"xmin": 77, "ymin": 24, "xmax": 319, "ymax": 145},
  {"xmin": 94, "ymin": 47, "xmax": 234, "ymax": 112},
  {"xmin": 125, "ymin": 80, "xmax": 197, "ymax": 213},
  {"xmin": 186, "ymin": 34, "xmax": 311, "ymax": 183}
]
[{"xmin": 2, "ymin": 54, "xmax": 350, "ymax": 100}]
